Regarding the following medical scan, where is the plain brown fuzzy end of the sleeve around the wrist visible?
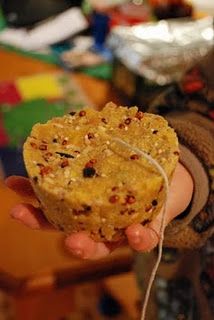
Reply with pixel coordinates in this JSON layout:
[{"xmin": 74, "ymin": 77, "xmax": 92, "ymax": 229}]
[{"xmin": 164, "ymin": 112, "xmax": 214, "ymax": 248}]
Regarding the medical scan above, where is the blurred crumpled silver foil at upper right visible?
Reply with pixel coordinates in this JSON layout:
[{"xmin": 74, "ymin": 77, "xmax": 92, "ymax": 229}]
[{"xmin": 107, "ymin": 17, "xmax": 214, "ymax": 86}]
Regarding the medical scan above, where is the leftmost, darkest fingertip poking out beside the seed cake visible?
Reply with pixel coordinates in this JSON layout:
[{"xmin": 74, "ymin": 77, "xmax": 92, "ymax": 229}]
[{"xmin": 5, "ymin": 176, "xmax": 35, "ymax": 198}]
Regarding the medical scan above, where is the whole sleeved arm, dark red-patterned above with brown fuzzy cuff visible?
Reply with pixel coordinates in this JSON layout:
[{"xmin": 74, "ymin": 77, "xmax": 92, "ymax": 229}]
[{"xmin": 149, "ymin": 48, "xmax": 214, "ymax": 248}]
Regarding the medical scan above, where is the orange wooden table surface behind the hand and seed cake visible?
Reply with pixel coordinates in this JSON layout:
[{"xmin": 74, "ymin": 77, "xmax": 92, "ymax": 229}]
[{"xmin": 0, "ymin": 50, "xmax": 132, "ymax": 290}]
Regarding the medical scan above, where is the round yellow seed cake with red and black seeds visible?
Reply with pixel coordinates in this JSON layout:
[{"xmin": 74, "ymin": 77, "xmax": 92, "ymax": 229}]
[{"xmin": 24, "ymin": 103, "xmax": 179, "ymax": 241}]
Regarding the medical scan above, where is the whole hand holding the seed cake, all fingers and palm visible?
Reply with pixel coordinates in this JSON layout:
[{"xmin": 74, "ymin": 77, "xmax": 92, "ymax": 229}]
[{"xmin": 5, "ymin": 164, "xmax": 193, "ymax": 259}]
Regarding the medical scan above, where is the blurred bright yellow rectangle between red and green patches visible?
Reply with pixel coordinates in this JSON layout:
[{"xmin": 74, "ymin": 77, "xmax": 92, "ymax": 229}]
[{"xmin": 16, "ymin": 74, "xmax": 62, "ymax": 100}]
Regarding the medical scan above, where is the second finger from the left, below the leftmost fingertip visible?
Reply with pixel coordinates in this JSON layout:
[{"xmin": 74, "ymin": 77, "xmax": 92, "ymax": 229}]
[{"xmin": 10, "ymin": 204, "xmax": 54, "ymax": 230}]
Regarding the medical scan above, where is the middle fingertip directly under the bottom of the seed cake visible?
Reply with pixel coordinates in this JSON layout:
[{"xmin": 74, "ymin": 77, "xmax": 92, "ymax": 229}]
[{"xmin": 65, "ymin": 232, "xmax": 110, "ymax": 260}]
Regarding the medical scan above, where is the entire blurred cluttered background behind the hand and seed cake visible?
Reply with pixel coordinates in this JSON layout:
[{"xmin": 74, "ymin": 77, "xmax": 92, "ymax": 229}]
[{"xmin": 0, "ymin": 0, "xmax": 214, "ymax": 320}]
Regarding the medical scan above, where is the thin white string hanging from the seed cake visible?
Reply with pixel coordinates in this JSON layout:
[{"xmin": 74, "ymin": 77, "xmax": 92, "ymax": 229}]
[{"xmin": 111, "ymin": 138, "xmax": 169, "ymax": 320}]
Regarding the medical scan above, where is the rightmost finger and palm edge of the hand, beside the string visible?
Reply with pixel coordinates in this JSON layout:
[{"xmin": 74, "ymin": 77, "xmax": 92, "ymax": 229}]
[{"xmin": 126, "ymin": 164, "xmax": 193, "ymax": 251}]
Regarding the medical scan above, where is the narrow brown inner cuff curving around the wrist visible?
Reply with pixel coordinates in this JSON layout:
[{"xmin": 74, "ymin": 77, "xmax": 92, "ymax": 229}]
[{"xmin": 164, "ymin": 145, "xmax": 213, "ymax": 248}]
